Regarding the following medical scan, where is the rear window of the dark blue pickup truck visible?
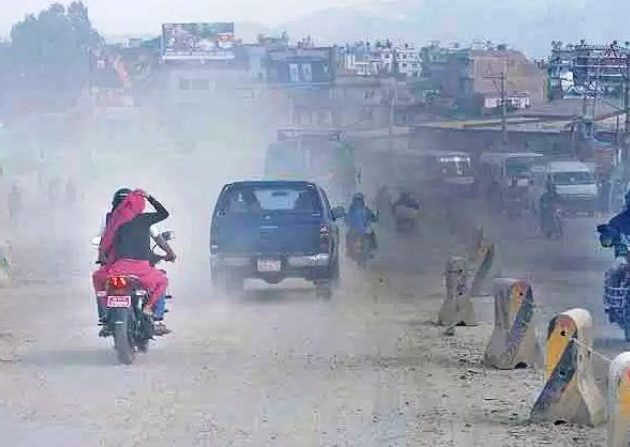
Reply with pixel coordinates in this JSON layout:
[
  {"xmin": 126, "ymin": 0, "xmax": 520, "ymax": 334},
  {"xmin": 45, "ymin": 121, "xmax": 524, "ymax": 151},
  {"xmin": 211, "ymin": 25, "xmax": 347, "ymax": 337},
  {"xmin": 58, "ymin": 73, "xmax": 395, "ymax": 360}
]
[{"xmin": 221, "ymin": 186, "xmax": 322, "ymax": 214}]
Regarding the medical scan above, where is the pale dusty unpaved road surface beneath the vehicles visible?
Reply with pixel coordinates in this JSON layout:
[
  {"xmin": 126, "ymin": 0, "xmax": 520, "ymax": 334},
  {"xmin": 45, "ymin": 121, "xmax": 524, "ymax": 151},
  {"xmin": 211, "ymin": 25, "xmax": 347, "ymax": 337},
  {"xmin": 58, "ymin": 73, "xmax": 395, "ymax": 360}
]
[{"xmin": 0, "ymin": 208, "xmax": 619, "ymax": 447}]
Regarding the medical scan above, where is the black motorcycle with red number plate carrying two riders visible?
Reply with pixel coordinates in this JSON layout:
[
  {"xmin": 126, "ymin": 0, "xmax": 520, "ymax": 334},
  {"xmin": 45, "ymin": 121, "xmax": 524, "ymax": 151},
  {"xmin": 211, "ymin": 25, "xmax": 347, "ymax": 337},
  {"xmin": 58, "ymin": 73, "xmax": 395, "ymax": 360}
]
[{"xmin": 93, "ymin": 231, "xmax": 174, "ymax": 365}]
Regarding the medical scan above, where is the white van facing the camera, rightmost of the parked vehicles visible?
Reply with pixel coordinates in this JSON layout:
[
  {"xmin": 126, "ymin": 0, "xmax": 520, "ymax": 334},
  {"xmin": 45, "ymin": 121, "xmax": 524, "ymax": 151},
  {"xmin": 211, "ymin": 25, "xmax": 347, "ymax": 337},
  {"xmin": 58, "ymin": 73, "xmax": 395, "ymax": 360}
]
[{"xmin": 529, "ymin": 161, "xmax": 599, "ymax": 215}]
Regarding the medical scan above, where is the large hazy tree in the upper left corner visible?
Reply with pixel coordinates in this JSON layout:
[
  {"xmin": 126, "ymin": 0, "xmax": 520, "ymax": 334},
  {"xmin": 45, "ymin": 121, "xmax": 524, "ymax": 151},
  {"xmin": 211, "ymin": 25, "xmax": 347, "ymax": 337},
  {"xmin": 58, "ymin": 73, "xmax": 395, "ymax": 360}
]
[{"xmin": 11, "ymin": 1, "xmax": 103, "ymax": 93}]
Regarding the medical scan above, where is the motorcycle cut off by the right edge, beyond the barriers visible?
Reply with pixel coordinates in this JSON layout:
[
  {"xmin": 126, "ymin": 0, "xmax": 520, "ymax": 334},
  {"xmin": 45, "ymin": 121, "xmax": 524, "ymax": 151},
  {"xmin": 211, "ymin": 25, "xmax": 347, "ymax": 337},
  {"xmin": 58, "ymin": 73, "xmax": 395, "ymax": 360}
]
[{"xmin": 597, "ymin": 225, "xmax": 630, "ymax": 341}]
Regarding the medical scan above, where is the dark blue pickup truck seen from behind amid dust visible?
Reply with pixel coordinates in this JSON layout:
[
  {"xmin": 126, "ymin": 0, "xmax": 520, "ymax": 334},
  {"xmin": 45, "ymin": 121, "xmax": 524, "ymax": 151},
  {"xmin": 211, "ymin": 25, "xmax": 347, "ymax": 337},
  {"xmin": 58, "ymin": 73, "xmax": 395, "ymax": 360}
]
[{"xmin": 210, "ymin": 181, "xmax": 344, "ymax": 298}]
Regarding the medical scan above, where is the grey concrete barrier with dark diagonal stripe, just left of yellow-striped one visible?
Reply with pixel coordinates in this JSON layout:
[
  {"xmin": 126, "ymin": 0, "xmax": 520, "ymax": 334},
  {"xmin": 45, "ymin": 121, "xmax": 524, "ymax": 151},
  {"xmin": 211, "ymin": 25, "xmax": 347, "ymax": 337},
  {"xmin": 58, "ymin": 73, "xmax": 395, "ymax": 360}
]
[{"xmin": 484, "ymin": 278, "xmax": 543, "ymax": 369}]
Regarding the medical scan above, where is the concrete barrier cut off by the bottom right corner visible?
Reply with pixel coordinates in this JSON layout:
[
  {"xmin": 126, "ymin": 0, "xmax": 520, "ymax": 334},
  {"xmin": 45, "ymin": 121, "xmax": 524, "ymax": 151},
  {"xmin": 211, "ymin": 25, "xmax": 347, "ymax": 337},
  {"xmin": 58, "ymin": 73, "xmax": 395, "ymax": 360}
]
[{"xmin": 607, "ymin": 352, "xmax": 630, "ymax": 447}]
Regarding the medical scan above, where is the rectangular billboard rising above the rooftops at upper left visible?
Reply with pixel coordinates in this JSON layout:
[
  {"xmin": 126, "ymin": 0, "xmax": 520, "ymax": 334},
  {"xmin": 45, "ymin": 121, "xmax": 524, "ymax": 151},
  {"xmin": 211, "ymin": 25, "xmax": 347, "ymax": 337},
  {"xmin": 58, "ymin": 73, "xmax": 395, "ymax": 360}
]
[{"xmin": 162, "ymin": 23, "xmax": 235, "ymax": 61}]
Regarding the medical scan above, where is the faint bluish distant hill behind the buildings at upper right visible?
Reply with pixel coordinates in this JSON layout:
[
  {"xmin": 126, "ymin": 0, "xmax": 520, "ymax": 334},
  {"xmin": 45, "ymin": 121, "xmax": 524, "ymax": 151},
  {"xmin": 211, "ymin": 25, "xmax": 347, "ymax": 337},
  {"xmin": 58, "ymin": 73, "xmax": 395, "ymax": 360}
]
[{"xmin": 278, "ymin": 0, "xmax": 630, "ymax": 57}]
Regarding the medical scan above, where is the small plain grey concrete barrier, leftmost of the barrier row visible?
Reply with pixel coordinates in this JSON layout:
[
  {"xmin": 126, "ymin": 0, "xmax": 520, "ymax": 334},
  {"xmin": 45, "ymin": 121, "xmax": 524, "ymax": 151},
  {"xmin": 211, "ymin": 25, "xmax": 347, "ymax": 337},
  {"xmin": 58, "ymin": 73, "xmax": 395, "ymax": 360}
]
[{"xmin": 438, "ymin": 257, "xmax": 477, "ymax": 326}]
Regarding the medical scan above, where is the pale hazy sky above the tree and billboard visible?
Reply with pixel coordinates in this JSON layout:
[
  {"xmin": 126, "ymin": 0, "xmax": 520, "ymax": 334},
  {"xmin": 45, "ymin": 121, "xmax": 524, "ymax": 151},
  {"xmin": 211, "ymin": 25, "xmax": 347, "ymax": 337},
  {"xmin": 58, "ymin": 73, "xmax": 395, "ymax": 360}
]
[{"xmin": 0, "ymin": 0, "xmax": 360, "ymax": 36}]
